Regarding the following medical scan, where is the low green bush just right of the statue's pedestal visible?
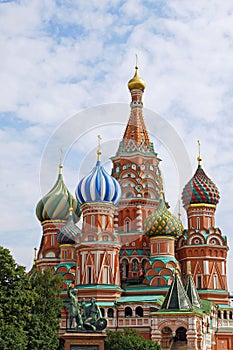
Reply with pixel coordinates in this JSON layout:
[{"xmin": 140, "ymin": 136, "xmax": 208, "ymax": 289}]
[{"xmin": 104, "ymin": 328, "xmax": 161, "ymax": 350}]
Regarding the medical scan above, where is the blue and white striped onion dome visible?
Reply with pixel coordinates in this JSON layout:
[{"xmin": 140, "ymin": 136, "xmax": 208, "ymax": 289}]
[{"xmin": 76, "ymin": 160, "xmax": 121, "ymax": 205}]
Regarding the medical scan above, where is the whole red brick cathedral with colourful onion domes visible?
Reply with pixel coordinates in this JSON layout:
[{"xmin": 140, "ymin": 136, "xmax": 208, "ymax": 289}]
[{"xmin": 35, "ymin": 67, "xmax": 233, "ymax": 350}]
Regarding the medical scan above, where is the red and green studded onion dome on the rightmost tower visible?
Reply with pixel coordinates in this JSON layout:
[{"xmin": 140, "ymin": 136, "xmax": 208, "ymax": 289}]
[{"xmin": 182, "ymin": 165, "xmax": 220, "ymax": 207}]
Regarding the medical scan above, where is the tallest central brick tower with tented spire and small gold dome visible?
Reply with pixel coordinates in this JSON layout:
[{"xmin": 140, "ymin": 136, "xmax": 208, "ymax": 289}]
[{"xmin": 112, "ymin": 67, "xmax": 162, "ymax": 281}]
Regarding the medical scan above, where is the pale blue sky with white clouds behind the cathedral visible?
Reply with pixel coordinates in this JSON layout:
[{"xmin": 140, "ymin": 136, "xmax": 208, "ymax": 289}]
[{"xmin": 0, "ymin": 0, "xmax": 233, "ymax": 290}]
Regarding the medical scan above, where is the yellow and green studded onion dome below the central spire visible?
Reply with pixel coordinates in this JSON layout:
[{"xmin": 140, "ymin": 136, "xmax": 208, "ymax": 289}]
[{"xmin": 144, "ymin": 198, "xmax": 184, "ymax": 237}]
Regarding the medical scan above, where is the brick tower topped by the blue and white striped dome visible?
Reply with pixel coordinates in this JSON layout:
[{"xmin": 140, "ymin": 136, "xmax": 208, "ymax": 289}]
[{"xmin": 76, "ymin": 142, "xmax": 121, "ymax": 301}]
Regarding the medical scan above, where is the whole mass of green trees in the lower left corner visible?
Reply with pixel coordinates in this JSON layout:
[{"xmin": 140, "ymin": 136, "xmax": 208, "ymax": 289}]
[{"xmin": 0, "ymin": 247, "xmax": 62, "ymax": 350}]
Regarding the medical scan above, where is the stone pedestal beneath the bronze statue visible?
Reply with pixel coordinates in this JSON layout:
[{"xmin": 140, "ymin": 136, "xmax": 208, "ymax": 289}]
[{"xmin": 62, "ymin": 332, "xmax": 106, "ymax": 350}]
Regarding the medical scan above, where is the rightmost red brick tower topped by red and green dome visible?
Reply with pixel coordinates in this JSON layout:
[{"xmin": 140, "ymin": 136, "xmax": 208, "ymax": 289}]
[{"xmin": 176, "ymin": 145, "xmax": 229, "ymax": 304}]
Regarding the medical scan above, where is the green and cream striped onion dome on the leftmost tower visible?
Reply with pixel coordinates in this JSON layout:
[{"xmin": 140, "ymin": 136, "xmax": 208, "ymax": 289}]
[{"xmin": 36, "ymin": 164, "xmax": 81, "ymax": 223}]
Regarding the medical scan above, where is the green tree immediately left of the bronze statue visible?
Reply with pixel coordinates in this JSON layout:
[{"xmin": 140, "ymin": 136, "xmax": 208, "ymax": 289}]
[{"xmin": 28, "ymin": 268, "xmax": 62, "ymax": 350}]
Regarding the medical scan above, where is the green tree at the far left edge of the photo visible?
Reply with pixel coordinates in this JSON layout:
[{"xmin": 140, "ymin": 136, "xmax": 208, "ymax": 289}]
[{"xmin": 0, "ymin": 247, "xmax": 33, "ymax": 350}]
